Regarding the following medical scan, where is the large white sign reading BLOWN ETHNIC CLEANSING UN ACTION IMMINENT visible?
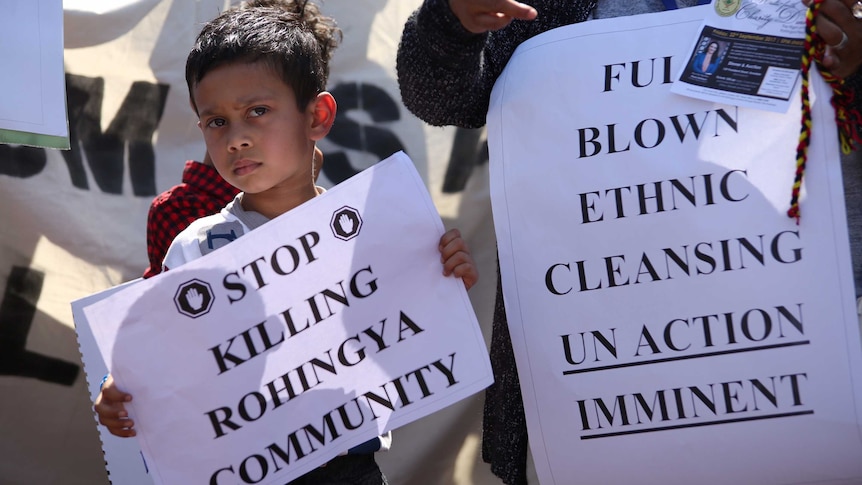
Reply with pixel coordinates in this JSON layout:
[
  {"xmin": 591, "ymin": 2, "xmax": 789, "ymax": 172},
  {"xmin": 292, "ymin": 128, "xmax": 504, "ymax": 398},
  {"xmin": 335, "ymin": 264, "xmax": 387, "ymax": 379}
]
[{"xmin": 488, "ymin": 9, "xmax": 862, "ymax": 485}]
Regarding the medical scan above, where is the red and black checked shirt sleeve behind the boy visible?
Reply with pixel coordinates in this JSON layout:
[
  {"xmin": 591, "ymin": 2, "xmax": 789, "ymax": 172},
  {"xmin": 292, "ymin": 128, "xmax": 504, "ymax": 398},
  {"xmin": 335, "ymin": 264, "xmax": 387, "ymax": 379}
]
[{"xmin": 144, "ymin": 160, "xmax": 239, "ymax": 278}]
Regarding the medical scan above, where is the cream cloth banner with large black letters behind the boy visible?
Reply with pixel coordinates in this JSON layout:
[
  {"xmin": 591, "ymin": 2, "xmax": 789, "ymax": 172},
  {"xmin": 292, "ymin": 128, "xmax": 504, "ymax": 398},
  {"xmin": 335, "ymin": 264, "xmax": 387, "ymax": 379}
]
[{"xmin": 0, "ymin": 0, "xmax": 497, "ymax": 485}]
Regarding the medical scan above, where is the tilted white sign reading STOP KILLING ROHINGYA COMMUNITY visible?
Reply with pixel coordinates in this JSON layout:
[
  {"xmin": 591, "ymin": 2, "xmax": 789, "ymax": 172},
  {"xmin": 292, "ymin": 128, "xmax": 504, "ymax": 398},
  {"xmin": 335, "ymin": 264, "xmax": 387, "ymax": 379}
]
[{"xmin": 84, "ymin": 153, "xmax": 492, "ymax": 485}]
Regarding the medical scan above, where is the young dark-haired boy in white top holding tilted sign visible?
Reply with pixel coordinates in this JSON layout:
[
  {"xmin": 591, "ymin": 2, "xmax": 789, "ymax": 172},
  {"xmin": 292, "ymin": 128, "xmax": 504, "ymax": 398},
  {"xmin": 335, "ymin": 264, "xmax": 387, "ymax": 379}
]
[{"xmin": 95, "ymin": 2, "xmax": 486, "ymax": 485}]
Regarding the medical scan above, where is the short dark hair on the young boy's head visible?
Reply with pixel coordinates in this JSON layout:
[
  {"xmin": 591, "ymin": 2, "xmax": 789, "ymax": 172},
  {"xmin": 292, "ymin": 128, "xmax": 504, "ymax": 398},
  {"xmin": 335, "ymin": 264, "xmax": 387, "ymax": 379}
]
[{"xmin": 186, "ymin": 0, "xmax": 342, "ymax": 111}]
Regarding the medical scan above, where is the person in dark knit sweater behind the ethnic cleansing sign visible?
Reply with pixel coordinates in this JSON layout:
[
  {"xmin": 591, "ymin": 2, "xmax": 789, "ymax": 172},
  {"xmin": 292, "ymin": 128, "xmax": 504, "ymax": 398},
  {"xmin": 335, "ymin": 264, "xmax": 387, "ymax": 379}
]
[{"xmin": 396, "ymin": 0, "xmax": 862, "ymax": 485}]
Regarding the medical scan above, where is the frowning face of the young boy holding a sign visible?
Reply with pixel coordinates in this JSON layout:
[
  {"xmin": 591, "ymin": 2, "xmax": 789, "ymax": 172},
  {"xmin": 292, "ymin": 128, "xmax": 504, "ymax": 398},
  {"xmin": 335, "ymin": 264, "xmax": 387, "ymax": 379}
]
[{"xmin": 192, "ymin": 63, "xmax": 314, "ymax": 204}]
